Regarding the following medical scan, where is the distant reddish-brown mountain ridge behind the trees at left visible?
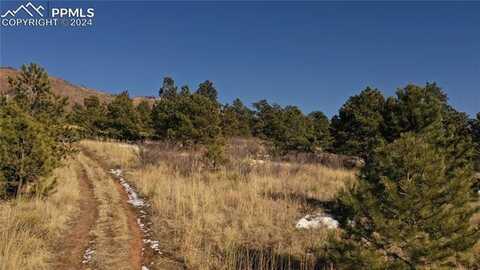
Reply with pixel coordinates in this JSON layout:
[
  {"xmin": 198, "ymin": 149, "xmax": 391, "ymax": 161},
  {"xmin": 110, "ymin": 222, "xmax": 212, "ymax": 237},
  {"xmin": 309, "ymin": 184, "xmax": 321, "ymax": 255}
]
[{"xmin": 0, "ymin": 67, "xmax": 154, "ymax": 107}]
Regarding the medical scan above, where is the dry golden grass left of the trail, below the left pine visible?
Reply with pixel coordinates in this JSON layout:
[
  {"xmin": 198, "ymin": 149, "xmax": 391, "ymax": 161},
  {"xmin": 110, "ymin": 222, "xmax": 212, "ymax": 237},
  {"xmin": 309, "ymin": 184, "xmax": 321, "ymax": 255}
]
[{"xmin": 0, "ymin": 160, "xmax": 80, "ymax": 270}]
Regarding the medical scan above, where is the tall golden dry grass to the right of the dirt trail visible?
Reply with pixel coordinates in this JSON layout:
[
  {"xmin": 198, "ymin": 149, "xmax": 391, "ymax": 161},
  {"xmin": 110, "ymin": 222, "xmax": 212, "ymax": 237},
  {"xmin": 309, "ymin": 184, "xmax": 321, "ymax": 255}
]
[{"xmin": 84, "ymin": 141, "xmax": 354, "ymax": 269}]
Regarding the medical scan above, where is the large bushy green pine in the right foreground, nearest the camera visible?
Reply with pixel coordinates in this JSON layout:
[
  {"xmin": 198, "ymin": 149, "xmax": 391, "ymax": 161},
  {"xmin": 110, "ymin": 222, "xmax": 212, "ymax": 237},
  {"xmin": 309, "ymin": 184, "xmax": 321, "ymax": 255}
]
[{"xmin": 330, "ymin": 132, "xmax": 480, "ymax": 269}]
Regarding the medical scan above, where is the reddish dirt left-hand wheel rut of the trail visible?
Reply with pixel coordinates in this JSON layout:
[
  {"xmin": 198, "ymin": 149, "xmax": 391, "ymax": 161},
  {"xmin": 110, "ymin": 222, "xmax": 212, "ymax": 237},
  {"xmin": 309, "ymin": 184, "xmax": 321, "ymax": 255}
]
[{"xmin": 55, "ymin": 158, "xmax": 98, "ymax": 270}]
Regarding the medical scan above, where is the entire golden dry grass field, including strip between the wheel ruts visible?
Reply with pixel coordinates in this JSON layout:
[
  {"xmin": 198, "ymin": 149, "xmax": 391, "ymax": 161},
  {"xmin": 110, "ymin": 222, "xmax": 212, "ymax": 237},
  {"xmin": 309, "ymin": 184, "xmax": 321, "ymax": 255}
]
[{"xmin": 0, "ymin": 141, "xmax": 480, "ymax": 270}]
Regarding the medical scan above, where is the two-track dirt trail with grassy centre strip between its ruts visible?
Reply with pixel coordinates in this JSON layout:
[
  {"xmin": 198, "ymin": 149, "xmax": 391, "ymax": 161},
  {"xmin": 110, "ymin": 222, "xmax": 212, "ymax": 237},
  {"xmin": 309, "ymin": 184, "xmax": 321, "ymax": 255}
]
[{"xmin": 55, "ymin": 151, "xmax": 145, "ymax": 270}]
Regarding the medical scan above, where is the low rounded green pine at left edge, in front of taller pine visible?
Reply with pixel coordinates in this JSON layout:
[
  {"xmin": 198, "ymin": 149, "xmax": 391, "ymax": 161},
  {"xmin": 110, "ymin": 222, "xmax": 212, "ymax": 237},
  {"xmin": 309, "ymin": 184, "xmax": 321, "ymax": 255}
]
[{"xmin": 0, "ymin": 102, "xmax": 61, "ymax": 198}]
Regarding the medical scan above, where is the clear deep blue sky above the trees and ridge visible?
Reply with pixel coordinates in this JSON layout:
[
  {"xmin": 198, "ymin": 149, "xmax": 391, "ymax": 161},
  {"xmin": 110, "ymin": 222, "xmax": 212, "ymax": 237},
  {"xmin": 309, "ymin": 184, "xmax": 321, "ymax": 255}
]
[{"xmin": 0, "ymin": 1, "xmax": 480, "ymax": 116}]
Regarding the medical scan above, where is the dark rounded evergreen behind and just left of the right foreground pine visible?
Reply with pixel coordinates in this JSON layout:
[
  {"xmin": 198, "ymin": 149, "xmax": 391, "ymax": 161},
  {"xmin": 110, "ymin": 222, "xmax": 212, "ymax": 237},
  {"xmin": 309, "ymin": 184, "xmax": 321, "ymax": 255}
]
[{"xmin": 331, "ymin": 87, "xmax": 385, "ymax": 158}]
